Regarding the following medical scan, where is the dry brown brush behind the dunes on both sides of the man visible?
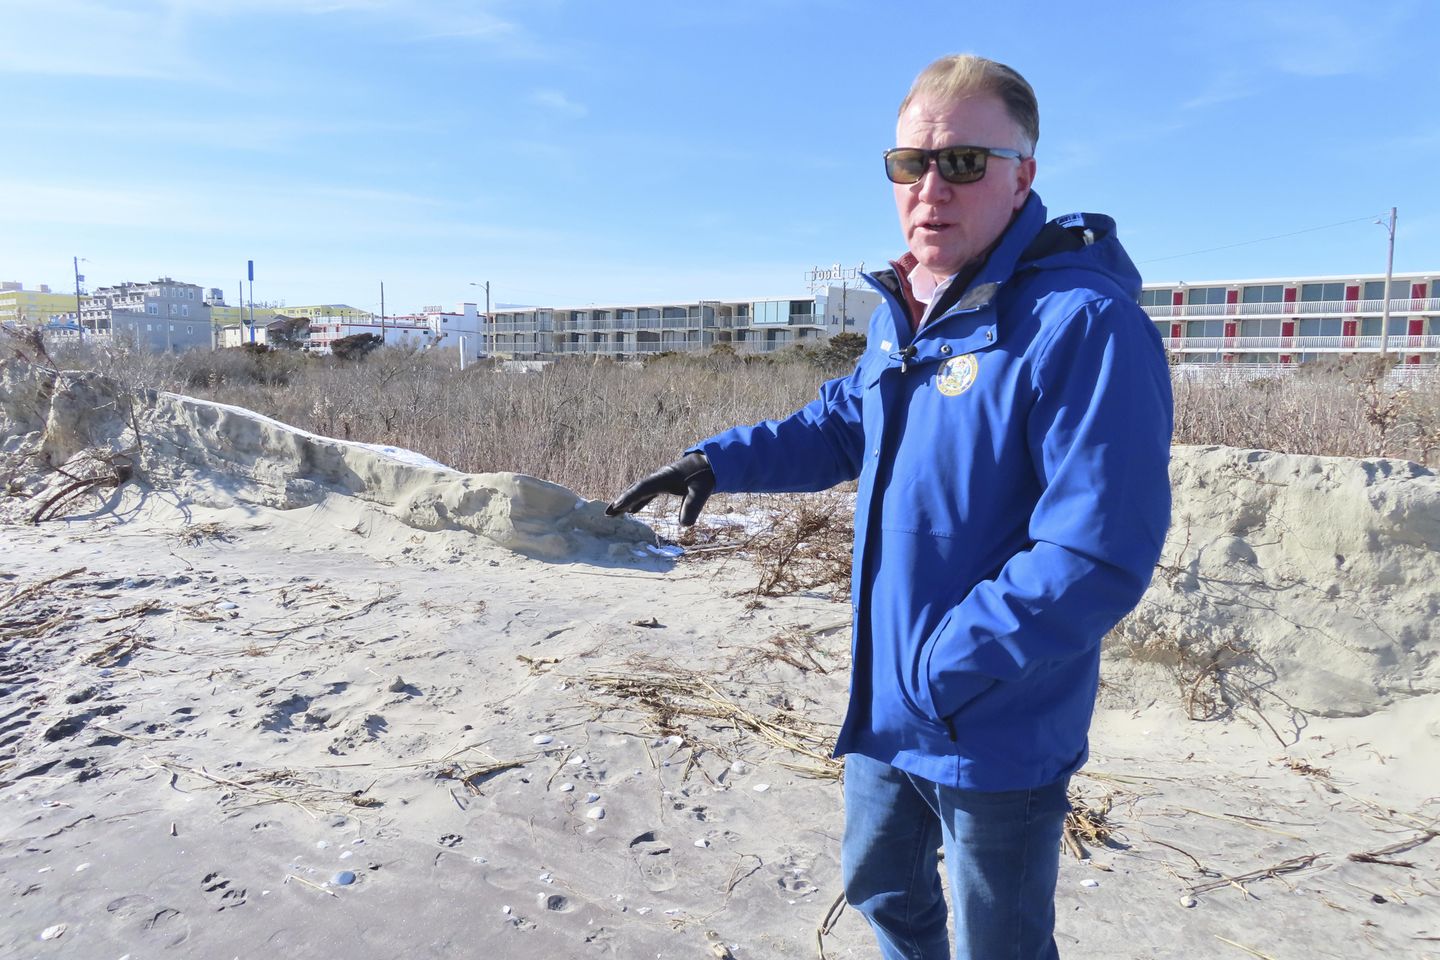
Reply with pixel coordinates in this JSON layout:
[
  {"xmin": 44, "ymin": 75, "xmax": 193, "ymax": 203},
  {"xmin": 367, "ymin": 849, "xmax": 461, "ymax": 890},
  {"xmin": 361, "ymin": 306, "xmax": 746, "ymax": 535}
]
[{"xmin": 39, "ymin": 344, "xmax": 1440, "ymax": 497}]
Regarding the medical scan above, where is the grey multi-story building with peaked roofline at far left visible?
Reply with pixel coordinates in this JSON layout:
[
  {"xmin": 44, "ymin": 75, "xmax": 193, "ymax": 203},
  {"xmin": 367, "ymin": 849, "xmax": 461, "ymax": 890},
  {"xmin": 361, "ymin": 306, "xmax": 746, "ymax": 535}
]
[{"xmin": 81, "ymin": 276, "xmax": 215, "ymax": 351}]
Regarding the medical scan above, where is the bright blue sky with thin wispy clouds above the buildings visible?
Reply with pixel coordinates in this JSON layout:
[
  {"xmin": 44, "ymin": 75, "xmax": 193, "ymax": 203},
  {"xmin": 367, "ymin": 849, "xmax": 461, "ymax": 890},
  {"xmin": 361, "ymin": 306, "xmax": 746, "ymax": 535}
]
[{"xmin": 0, "ymin": 0, "xmax": 1440, "ymax": 312}]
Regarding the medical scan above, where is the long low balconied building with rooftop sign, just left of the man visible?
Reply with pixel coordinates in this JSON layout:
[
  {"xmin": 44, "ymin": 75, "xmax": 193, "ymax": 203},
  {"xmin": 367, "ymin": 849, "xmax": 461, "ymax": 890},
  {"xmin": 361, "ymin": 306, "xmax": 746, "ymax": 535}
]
[{"xmin": 485, "ymin": 285, "xmax": 880, "ymax": 360}]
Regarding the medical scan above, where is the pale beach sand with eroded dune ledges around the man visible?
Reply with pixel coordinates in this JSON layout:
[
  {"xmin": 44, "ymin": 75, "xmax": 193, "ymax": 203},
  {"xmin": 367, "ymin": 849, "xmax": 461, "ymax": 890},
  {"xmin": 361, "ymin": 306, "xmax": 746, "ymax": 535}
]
[{"xmin": 0, "ymin": 362, "xmax": 1440, "ymax": 960}]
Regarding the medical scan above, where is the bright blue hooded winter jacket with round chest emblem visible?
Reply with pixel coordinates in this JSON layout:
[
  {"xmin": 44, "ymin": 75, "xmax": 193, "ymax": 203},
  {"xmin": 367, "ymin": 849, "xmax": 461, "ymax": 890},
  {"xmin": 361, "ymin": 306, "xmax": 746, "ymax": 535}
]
[{"xmin": 694, "ymin": 194, "xmax": 1172, "ymax": 790}]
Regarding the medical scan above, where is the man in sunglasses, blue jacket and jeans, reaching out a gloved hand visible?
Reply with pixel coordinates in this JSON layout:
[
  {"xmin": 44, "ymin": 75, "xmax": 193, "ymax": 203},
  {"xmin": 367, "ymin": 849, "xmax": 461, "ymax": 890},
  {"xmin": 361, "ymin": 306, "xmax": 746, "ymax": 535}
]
[{"xmin": 609, "ymin": 56, "xmax": 1172, "ymax": 960}]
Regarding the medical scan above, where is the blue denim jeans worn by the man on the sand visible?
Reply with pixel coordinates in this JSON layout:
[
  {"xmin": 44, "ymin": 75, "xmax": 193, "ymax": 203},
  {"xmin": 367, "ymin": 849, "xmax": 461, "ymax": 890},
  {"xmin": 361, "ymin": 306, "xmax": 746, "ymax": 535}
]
[{"xmin": 841, "ymin": 754, "xmax": 1070, "ymax": 960}]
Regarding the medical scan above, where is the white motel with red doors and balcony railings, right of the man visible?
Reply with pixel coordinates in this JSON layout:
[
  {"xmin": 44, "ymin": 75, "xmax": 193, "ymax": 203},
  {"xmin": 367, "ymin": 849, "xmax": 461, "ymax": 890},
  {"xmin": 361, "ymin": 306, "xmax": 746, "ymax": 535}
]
[{"xmin": 1140, "ymin": 271, "xmax": 1440, "ymax": 373}]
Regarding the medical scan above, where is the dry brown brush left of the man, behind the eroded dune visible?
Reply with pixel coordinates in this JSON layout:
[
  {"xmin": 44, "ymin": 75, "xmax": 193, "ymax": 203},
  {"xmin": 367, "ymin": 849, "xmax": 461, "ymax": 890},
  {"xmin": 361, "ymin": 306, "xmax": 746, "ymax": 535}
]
[{"xmin": 45, "ymin": 341, "xmax": 825, "ymax": 498}]
